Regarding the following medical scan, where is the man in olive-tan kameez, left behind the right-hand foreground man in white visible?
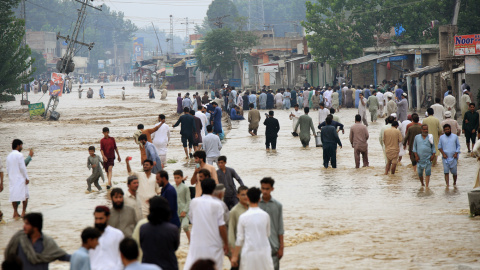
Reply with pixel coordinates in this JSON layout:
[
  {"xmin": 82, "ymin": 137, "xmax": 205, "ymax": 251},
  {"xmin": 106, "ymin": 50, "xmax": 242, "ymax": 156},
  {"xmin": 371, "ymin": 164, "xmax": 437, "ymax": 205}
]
[{"xmin": 228, "ymin": 186, "xmax": 248, "ymax": 270}]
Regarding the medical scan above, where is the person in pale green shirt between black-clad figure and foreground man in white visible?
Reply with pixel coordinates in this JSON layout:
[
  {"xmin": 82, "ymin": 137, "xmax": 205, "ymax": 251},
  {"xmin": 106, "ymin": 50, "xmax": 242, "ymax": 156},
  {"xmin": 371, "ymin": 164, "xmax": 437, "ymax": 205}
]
[{"xmin": 173, "ymin": 170, "xmax": 192, "ymax": 243}]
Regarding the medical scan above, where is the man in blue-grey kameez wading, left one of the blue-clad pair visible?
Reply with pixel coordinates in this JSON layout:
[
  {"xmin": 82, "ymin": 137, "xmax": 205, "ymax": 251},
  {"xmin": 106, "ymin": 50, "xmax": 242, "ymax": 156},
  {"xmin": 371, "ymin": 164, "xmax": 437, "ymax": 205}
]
[{"xmin": 413, "ymin": 124, "xmax": 436, "ymax": 188}]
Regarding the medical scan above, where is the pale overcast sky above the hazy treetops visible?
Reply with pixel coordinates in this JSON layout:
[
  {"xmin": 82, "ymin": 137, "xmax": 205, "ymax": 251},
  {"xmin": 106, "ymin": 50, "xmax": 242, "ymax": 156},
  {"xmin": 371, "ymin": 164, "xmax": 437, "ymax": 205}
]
[{"xmin": 98, "ymin": 0, "xmax": 212, "ymax": 34}]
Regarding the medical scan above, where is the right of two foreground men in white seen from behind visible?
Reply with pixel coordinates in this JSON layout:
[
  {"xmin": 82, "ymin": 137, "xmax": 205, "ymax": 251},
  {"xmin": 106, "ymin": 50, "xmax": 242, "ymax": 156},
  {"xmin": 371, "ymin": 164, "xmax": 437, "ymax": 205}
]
[{"xmin": 232, "ymin": 187, "xmax": 273, "ymax": 270}]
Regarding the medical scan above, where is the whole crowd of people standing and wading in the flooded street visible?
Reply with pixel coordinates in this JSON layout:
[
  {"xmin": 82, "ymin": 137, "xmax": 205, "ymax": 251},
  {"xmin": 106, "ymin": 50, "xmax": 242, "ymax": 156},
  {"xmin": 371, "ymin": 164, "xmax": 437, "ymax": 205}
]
[{"xmin": 0, "ymin": 77, "xmax": 480, "ymax": 270}]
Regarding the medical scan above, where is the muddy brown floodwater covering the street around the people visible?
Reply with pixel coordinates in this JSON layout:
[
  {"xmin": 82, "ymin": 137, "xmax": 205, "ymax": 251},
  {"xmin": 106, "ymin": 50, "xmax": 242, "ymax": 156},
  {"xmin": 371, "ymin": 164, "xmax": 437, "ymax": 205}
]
[{"xmin": 0, "ymin": 82, "xmax": 480, "ymax": 269}]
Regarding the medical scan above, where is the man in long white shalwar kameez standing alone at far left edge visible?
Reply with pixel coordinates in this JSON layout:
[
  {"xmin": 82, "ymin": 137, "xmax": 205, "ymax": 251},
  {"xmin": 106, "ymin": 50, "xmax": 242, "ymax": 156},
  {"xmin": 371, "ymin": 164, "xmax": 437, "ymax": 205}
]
[{"xmin": 6, "ymin": 139, "xmax": 29, "ymax": 218}]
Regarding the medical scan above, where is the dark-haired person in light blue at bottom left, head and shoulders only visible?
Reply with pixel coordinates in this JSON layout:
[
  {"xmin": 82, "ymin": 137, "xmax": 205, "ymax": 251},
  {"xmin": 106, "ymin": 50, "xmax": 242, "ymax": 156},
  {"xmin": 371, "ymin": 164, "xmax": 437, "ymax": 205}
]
[{"xmin": 70, "ymin": 227, "xmax": 101, "ymax": 270}]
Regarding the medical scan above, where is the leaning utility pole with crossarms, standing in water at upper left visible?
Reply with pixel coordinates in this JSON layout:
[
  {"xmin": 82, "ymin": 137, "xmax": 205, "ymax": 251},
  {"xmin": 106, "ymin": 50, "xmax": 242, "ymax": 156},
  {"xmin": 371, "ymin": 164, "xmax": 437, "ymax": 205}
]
[{"xmin": 44, "ymin": 0, "xmax": 102, "ymax": 119}]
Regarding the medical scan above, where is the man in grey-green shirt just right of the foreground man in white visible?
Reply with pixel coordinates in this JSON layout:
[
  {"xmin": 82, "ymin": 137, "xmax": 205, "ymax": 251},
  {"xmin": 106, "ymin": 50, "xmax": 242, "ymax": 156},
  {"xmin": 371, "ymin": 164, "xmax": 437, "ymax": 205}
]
[{"xmin": 259, "ymin": 177, "xmax": 284, "ymax": 270}]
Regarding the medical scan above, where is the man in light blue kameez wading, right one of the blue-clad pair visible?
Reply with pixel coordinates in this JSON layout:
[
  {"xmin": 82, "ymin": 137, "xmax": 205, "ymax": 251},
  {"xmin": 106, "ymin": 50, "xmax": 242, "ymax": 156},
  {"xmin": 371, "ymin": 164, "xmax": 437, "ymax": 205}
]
[{"xmin": 438, "ymin": 124, "xmax": 460, "ymax": 187}]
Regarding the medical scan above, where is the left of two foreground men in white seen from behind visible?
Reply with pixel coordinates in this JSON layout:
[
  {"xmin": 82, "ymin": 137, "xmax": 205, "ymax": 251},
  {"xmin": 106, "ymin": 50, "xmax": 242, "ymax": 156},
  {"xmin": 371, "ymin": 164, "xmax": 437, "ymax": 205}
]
[{"xmin": 183, "ymin": 179, "xmax": 228, "ymax": 270}]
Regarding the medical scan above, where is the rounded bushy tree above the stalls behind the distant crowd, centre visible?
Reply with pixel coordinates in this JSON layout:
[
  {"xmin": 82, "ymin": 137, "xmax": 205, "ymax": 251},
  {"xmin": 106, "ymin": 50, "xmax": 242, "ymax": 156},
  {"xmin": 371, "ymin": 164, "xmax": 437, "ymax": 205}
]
[{"xmin": 195, "ymin": 24, "xmax": 258, "ymax": 85}]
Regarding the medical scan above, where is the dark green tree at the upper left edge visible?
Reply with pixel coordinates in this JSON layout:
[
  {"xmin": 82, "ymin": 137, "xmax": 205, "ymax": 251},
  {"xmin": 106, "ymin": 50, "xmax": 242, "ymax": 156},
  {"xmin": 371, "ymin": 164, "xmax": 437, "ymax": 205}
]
[{"xmin": 0, "ymin": 0, "xmax": 34, "ymax": 95}]
